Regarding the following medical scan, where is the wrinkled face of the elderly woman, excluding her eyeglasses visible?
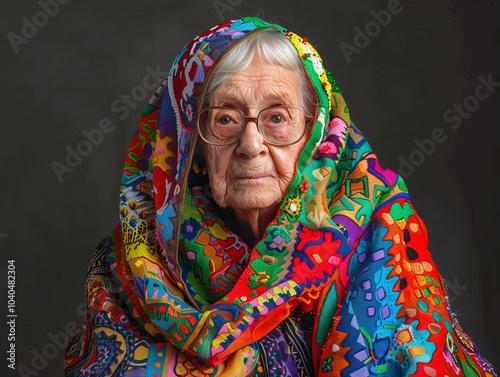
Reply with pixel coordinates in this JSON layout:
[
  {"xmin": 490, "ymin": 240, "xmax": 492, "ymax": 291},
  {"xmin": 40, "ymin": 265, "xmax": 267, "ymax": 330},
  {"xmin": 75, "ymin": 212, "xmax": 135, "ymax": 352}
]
[{"xmin": 203, "ymin": 53, "xmax": 306, "ymax": 214}]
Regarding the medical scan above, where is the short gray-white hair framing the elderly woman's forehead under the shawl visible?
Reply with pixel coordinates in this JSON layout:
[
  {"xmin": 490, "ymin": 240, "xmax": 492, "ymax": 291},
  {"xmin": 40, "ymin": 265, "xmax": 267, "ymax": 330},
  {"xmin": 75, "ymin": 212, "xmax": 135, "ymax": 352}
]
[{"xmin": 201, "ymin": 30, "xmax": 316, "ymax": 115}]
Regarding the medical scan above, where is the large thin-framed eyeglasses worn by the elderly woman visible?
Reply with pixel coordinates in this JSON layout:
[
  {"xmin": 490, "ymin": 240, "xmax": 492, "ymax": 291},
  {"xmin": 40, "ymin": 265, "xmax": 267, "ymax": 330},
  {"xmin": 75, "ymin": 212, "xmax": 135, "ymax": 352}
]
[{"xmin": 196, "ymin": 106, "xmax": 312, "ymax": 146}]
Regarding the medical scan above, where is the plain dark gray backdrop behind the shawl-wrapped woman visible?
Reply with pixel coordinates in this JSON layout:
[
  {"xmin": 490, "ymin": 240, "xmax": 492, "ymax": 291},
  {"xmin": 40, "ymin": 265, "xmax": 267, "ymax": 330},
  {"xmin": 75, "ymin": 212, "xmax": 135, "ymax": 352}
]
[{"xmin": 0, "ymin": 0, "xmax": 500, "ymax": 377}]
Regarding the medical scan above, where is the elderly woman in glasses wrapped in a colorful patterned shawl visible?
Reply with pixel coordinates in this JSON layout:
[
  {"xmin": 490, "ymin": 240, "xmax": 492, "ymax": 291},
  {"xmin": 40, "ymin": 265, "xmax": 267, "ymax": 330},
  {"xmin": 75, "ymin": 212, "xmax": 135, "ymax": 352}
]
[{"xmin": 64, "ymin": 18, "xmax": 495, "ymax": 377}]
